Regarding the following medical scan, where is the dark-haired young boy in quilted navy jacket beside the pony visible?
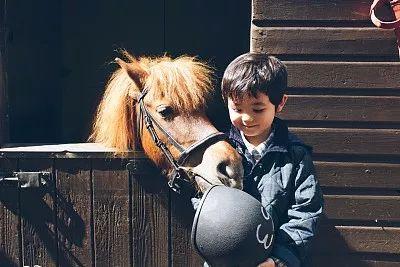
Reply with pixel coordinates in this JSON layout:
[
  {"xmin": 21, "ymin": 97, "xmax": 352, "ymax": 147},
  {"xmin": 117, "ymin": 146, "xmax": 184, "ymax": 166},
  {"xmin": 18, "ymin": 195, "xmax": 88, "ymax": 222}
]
[{"xmin": 222, "ymin": 53, "xmax": 323, "ymax": 267}]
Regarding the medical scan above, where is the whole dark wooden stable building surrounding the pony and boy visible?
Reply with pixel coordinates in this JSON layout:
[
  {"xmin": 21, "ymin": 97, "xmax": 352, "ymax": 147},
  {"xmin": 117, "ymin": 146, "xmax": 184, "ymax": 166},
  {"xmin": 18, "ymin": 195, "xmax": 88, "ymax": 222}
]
[{"xmin": 0, "ymin": 0, "xmax": 400, "ymax": 266}]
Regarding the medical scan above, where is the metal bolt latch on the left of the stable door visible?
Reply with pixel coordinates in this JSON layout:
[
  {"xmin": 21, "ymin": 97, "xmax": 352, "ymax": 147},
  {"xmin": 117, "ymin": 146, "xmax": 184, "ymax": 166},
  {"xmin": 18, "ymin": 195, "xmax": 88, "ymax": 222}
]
[{"xmin": 0, "ymin": 172, "xmax": 51, "ymax": 188}]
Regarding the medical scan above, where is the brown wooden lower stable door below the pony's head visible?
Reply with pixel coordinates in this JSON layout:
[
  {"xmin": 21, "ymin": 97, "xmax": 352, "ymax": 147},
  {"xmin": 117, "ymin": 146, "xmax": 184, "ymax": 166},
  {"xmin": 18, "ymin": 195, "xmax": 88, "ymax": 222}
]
[{"xmin": 0, "ymin": 145, "xmax": 202, "ymax": 267}]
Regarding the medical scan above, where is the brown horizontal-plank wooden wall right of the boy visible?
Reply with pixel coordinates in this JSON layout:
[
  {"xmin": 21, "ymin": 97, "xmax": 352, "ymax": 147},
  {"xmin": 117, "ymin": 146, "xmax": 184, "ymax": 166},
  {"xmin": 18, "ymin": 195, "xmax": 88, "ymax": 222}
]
[{"xmin": 251, "ymin": 0, "xmax": 400, "ymax": 266}]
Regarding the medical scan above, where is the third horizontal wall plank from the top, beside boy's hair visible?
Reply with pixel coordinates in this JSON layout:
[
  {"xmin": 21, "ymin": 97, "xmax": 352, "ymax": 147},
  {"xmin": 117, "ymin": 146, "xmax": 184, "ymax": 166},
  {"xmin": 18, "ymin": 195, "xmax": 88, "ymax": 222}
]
[{"xmin": 285, "ymin": 61, "xmax": 400, "ymax": 90}]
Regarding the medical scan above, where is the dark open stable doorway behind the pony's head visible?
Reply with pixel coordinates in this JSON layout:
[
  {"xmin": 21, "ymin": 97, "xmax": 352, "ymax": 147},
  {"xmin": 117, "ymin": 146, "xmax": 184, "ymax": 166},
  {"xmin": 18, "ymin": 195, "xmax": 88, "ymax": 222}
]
[{"xmin": 0, "ymin": 0, "xmax": 251, "ymax": 143}]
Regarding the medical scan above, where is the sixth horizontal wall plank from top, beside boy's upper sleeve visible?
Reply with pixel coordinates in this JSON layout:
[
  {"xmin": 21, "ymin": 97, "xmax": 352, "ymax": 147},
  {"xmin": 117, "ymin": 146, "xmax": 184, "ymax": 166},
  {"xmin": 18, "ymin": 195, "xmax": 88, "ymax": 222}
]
[{"xmin": 314, "ymin": 161, "xmax": 400, "ymax": 189}]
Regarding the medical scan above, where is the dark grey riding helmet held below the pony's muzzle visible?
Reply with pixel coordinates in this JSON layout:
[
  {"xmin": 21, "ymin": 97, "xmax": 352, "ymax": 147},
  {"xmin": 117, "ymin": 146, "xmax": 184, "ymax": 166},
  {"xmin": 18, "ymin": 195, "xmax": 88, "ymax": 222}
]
[{"xmin": 191, "ymin": 185, "xmax": 274, "ymax": 267}]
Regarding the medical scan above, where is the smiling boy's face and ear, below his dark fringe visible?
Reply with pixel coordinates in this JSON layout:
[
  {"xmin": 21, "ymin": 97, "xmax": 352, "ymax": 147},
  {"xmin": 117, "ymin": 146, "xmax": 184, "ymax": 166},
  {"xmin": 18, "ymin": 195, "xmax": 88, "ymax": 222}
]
[{"xmin": 228, "ymin": 93, "xmax": 287, "ymax": 146}]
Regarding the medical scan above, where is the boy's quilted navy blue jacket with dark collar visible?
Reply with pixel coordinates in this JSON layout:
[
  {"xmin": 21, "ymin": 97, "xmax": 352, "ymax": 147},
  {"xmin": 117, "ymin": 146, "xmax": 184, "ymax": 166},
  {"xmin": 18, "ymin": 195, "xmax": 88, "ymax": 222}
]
[{"xmin": 229, "ymin": 118, "xmax": 323, "ymax": 267}]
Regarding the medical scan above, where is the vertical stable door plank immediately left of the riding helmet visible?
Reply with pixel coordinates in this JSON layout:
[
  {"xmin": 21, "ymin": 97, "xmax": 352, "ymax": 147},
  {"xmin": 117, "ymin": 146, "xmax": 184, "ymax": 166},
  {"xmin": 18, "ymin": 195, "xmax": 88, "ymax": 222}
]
[{"xmin": 170, "ymin": 192, "xmax": 204, "ymax": 267}]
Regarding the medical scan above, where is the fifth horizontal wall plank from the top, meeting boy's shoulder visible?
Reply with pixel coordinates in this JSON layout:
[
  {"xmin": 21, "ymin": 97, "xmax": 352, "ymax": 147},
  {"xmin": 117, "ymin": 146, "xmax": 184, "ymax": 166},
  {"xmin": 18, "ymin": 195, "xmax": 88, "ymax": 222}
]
[{"xmin": 290, "ymin": 128, "xmax": 400, "ymax": 156}]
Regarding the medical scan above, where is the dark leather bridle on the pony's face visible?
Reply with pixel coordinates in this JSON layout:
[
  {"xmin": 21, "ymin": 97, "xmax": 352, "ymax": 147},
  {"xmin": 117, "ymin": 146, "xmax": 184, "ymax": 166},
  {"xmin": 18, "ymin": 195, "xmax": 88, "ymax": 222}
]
[{"xmin": 138, "ymin": 88, "xmax": 226, "ymax": 193}]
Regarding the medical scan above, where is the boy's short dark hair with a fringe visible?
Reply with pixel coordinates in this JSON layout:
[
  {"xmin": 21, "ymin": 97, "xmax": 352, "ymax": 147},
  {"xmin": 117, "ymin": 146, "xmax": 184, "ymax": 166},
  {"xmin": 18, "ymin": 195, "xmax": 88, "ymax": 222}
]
[{"xmin": 221, "ymin": 53, "xmax": 287, "ymax": 106}]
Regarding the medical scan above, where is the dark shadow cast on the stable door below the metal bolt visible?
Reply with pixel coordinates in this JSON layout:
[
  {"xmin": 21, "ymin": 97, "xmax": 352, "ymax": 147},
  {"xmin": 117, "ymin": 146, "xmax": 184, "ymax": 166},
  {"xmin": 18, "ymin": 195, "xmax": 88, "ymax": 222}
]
[{"xmin": 0, "ymin": 176, "xmax": 85, "ymax": 266}]
